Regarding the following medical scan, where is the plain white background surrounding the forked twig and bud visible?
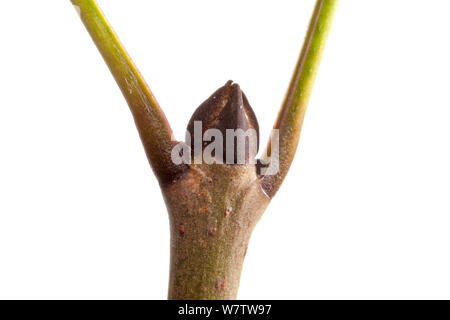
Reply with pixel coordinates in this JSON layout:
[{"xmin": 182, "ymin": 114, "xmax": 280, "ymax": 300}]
[{"xmin": 0, "ymin": 0, "xmax": 450, "ymax": 299}]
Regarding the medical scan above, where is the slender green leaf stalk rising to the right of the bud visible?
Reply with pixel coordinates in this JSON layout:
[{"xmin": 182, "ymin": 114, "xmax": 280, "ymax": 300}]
[{"xmin": 261, "ymin": 0, "xmax": 338, "ymax": 197}]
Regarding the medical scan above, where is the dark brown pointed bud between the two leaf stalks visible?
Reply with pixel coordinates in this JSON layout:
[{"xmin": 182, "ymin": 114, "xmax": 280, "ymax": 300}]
[{"xmin": 186, "ymin": 81, "xmax": 259, "ymax": 164}]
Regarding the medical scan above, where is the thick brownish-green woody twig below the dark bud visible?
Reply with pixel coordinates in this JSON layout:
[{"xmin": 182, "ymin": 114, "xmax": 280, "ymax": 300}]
[{"xmin": 162, "ymin": 164, "xmax": 269, "ymax": 299}]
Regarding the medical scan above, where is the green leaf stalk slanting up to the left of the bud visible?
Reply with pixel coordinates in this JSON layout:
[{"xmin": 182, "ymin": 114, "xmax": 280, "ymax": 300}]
[{"xmin": 71, "ymin": 0, "xmax": 183, "ymax": 183}]
